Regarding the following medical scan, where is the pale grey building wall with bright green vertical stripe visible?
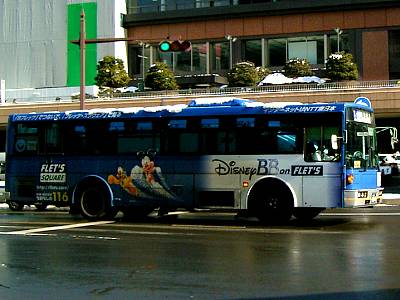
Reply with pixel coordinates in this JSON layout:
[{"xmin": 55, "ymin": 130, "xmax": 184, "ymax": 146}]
[{"xmin": 0, "ymin": 0, "xmax": 127, "ymax": 100}]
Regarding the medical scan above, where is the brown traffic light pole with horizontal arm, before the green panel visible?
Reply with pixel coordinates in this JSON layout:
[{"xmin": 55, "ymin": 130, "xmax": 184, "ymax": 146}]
[{"xmin": 70, "ymin": 9, "xmax": 134, "ymax": 110}]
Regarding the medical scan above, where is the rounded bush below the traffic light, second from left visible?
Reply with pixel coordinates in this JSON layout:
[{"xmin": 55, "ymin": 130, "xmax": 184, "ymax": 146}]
[{"xmin": 145, "ymin": 62, "xmax": 179, "ymax": 91}]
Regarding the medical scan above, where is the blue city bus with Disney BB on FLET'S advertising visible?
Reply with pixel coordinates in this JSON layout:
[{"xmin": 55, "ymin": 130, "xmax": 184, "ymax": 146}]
[{"xmin": 6, "ymin": 97, "xmax": 383, "ymax": 222}]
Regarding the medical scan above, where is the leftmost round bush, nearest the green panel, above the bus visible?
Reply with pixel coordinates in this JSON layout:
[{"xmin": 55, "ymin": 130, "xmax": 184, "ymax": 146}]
[{"xmin": 95, "ymin": 55, "xmax": 131, "ymax": 92}]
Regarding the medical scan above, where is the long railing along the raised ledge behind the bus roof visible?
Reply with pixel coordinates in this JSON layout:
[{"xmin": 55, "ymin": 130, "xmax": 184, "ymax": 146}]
[{"xmin": 3, "ymin": 80, "xmax": 400, "ymax": 105}]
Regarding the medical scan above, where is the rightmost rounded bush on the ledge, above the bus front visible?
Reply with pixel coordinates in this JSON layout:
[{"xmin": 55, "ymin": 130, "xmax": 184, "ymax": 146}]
[{"xmin": 326, "ymin": 52, "xmax": 358, "ymax": 81}]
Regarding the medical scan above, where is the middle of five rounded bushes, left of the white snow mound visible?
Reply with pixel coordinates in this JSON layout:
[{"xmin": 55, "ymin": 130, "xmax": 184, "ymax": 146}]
[{"xmin": 227, "ymin": 61, "xmax": 266, "ymax": 87}]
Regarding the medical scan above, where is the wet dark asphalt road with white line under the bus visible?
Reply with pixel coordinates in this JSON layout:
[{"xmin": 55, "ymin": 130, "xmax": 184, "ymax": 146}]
[{"xmin": 0, "ymin": 207, "xmax": 400, "ymax": 299}]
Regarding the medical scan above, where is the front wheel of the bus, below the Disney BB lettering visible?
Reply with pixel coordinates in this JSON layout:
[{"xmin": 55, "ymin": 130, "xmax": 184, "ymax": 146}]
[{"xmin": 249, "ymin": 180, "xmax": 293, "ymax": 224}]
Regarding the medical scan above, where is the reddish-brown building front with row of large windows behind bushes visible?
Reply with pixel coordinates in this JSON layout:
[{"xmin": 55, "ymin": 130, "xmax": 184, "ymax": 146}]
[{"xmin": 123, "ymin": 0, "xmax": 400, "ymax": 85}]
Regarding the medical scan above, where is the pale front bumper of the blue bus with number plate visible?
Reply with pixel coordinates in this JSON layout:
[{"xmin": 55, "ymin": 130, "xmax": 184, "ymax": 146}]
[{"xmin": 344, "ymin": 188, "xmax": 383, "ymax": 207}]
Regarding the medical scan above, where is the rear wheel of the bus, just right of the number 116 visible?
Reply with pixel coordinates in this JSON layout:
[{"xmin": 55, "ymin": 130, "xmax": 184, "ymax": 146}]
[{"xmin": 79, "ymin": 185, "xmax": 118, "ymax": 221}]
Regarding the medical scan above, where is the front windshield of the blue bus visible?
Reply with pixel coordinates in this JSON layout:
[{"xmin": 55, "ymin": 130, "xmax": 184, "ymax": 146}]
[{"xmin": 346, "ymin": 122, "xmax": 378, "ymax": 169}]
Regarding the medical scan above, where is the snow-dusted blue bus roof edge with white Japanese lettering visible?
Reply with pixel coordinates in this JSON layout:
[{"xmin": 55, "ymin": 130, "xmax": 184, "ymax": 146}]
[{"xmin": 9, "ymin": 97, "xmax": 372, "ymax": 122}]
